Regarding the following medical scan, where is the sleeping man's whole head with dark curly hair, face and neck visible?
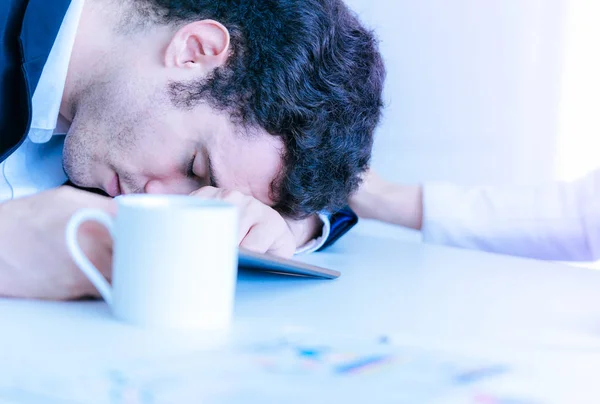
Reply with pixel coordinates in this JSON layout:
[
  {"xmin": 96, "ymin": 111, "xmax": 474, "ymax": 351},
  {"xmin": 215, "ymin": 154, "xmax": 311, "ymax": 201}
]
[{"xmin": 61, "ymin": 0, "xmax": 384, "ymax": 217}]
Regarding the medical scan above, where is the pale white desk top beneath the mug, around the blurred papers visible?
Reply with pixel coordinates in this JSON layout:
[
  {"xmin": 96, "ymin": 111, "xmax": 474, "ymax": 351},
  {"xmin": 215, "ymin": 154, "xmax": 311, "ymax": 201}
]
[{"xmin": 0, "ymin": 229, "xmax": 600, "ymax": 404}]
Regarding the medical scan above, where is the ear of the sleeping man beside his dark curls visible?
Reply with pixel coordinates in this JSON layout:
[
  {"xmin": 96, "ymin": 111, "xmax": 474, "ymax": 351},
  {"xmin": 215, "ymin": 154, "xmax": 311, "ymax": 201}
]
[{"xmin": 164, "ymin": 20, "xmax": 230, "ymax": 74}]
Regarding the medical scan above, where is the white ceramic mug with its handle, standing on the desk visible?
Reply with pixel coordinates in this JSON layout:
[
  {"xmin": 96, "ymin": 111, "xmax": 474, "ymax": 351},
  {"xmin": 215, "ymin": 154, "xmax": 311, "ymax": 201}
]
[{"xmin": 66, "ymin": 194, "xmax": 237, "ymax": 329}]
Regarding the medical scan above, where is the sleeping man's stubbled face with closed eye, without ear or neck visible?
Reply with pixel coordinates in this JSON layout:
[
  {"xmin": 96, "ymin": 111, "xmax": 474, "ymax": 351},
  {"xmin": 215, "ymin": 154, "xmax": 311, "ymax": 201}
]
[{"xmin": 64, "ymin": 66, "xmax": 283, "ymax": 205}]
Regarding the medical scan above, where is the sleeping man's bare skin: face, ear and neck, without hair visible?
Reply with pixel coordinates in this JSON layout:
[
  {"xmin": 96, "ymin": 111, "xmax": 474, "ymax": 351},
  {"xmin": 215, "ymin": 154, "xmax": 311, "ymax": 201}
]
[{"xmin": 61, "ymin": 15, "xmax": 283, "ymax": 205}]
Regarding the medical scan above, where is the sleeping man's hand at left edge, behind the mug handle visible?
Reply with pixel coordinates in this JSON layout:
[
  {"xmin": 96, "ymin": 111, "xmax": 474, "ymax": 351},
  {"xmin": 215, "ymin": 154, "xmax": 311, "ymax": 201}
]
[{"xmin": 0, "ymin": 187, "xmax": 116, "ymax": 300}]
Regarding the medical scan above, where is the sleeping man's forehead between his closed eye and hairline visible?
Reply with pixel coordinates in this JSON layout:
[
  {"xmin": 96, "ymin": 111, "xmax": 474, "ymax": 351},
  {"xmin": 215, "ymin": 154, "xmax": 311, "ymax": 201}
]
[{"xmin": 209, "ymin": 124, "xmax": 284, "ymax": 205}]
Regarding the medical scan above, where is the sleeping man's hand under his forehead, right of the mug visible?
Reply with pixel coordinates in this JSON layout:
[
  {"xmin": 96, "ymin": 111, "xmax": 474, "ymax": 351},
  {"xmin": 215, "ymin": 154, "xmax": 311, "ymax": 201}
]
[{"xmin": 192, "ymin": 187, "xmax": 318, "ymax": 258}]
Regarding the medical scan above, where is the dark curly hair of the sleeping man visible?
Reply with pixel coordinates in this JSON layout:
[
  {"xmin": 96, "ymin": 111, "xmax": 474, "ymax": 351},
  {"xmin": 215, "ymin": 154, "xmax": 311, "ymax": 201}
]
[{"xmin": 133, "ymin": 0, "xmax": 385, "ymax": 218}]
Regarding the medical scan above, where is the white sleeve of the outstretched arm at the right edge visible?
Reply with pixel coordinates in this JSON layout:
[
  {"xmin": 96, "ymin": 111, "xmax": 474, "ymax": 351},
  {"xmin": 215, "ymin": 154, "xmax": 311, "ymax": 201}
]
[{"xmin": 423, "ymin": 170, "xmax": 600, "ymax": 261}]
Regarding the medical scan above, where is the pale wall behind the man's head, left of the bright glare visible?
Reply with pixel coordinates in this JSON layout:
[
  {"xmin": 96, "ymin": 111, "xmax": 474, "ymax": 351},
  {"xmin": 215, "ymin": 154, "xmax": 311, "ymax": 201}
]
[{"xmin": 348, "ymin": 0, "xmax": 565, "ymax": 184}]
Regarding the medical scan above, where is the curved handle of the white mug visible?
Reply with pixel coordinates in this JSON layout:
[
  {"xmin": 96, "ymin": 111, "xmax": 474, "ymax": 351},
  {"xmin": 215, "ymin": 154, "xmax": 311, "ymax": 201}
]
[{"xmin": 65, "ymin": 209, "xmax": 114, "ymax": 306}]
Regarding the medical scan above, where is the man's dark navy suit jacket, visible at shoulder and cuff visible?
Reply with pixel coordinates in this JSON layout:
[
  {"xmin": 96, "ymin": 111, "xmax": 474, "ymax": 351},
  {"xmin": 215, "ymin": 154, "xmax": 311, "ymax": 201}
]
[{"xmin": 0, "ymin": 0, "xmax": 357, "ymax": 248}]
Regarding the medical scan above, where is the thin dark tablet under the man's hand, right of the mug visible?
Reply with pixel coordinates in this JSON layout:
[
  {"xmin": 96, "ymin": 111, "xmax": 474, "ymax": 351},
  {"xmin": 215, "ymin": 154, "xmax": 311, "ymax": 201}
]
[{"xmin": 238, "ymin": 248, "xmax": 340, "ymax": 279}]
